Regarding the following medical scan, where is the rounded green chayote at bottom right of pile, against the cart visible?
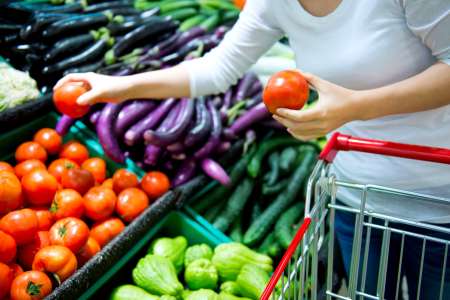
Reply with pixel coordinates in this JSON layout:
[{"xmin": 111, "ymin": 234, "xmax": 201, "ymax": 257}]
[{"xmin": 236, "ymin": 265, "xmax": 270, "ymax": 300}]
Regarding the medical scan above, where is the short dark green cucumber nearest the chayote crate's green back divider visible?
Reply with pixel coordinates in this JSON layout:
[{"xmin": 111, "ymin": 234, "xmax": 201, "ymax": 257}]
[{"xmin": 213, "ymin": 178, "xmax": 254, "ymax": 232}]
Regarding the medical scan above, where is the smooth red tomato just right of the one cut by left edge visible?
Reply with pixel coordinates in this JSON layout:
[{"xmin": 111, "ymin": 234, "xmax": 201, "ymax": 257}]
[{"xmin": 22, "ymin": 170, "xmax": 58, "ymax": 206}]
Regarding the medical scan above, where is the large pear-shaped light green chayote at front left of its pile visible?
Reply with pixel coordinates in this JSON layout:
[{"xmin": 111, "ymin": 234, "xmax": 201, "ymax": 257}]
[{"xmin": 133, "ymin": 254, "xmax": 183, "ymax": 297}]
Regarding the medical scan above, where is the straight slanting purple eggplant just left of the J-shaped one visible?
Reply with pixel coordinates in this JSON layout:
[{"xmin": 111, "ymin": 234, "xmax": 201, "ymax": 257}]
[{"xmin": 125, "ymin": 98, "xmax": 176, "ymax": 146}]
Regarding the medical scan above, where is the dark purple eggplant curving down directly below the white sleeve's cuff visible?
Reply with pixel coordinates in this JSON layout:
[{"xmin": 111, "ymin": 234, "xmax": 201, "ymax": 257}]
[{"xmin": 184, "ymin": 97, "xmax": 212, "ymax": 147}]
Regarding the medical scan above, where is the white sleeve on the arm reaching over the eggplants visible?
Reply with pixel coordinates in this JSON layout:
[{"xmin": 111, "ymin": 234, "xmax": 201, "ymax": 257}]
[{"xmin": 183, "ymin": 0, "xmax": 283, "ymax": 97}]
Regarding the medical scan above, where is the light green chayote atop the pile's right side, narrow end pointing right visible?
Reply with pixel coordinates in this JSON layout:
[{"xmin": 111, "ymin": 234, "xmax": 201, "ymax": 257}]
[{"xmin": 212, "ymin": 243, "xmax": 273, "ymax": 281}]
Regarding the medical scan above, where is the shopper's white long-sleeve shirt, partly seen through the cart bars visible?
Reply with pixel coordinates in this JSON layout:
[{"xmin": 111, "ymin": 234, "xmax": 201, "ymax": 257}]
[{"xmin": 186, "ymin": 0, "xmax": 450, "ymax": 222}]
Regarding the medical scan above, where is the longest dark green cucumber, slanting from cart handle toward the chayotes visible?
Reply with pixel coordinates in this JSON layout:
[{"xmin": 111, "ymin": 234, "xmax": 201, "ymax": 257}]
[{"xmin": 244, "ymin": 147, "xmax": 316, "ymax": 246}]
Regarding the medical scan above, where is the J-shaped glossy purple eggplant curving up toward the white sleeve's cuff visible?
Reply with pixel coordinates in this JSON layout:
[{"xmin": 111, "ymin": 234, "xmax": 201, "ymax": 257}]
[{"xmin": 144, "ymin": 98, "xmax": 195, "ymax": 147}]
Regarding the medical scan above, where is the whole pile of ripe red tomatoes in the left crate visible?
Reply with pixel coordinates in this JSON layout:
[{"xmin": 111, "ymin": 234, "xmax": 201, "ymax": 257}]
[{"xmin": 0, "ymin": 128, "xmax": 170, "ymax": 300}]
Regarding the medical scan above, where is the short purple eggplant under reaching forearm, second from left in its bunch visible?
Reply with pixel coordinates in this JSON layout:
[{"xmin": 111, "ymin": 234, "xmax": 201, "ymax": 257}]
[{"xmin": 115, "ymin": 100, "xmax": 156, "ymax": 137}]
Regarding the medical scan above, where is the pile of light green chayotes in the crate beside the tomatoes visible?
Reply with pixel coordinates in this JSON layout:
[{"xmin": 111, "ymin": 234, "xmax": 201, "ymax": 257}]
[{"xmin": 110, "ymin": 236, "xmax": 290, "ymax": 300}]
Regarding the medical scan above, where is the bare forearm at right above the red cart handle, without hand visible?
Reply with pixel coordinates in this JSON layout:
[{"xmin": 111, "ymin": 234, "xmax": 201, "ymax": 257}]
[{"xmin": 355, "ymin": 62, "xmax": 450, "ymax": 120}]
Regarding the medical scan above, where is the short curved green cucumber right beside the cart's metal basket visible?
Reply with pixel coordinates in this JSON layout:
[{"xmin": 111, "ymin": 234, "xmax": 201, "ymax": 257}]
[{"xmin": 275, "ymin": 202, "xmax": 305, "ymax": 249}]
